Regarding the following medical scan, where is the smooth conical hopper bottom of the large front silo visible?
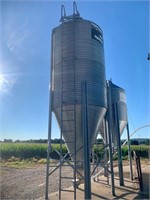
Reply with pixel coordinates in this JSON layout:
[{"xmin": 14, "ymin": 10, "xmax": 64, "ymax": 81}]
[{"xmin": 54, "ymin": 104, "xmax": 106, "ymax": 176}]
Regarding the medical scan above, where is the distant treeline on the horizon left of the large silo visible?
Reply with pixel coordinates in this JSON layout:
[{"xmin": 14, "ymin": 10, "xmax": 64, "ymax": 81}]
[{"xmin": 0, "ymin": 138, "xmax": 65, "ymax": 144}]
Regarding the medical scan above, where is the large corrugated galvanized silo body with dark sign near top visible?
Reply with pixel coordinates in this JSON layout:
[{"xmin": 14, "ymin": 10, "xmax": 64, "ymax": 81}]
[{"xmin": 51, "ymin": 15, "xmax": 107, "ymax": 164}]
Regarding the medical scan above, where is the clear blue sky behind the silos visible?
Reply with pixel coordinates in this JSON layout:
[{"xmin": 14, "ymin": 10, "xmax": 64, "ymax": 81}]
[{"xmin": 0, "ymin": 0, "xmax": 150, "ymax": 140}]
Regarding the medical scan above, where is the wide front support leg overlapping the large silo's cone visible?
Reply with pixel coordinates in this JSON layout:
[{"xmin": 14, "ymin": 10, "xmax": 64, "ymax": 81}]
[{"xmin": 82, "ymin": 82, "xmax": 91, "ymax": 199}]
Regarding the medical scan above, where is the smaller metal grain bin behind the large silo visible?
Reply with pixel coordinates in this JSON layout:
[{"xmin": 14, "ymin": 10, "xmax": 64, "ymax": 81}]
[{"xmin": 99, "ymin": 81, "xmax": 127, "ymax": 146}]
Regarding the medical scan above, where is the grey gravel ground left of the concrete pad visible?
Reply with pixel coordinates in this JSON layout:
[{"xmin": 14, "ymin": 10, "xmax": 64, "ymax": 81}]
[{"xmin": 0, "ymin": 165, "xmax": 72, "ymax": 200}]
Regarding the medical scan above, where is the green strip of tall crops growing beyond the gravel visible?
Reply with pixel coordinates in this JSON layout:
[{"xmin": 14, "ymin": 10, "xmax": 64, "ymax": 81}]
[{"xmin": 0, "ymin": 143, "xmax": 150, "ymax": 159}]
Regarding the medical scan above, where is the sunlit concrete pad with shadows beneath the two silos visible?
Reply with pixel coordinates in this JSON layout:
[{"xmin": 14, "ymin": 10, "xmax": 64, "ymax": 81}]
[{"xmin": 38, "ymin": 164, "xmax": 150, "ymax": 200}]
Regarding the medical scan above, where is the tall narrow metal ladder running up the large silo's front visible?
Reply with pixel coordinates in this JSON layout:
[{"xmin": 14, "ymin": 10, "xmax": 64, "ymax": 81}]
[{"xmin": 59, "ymin": 19, "xmax": 77, "ymax": 199}]
